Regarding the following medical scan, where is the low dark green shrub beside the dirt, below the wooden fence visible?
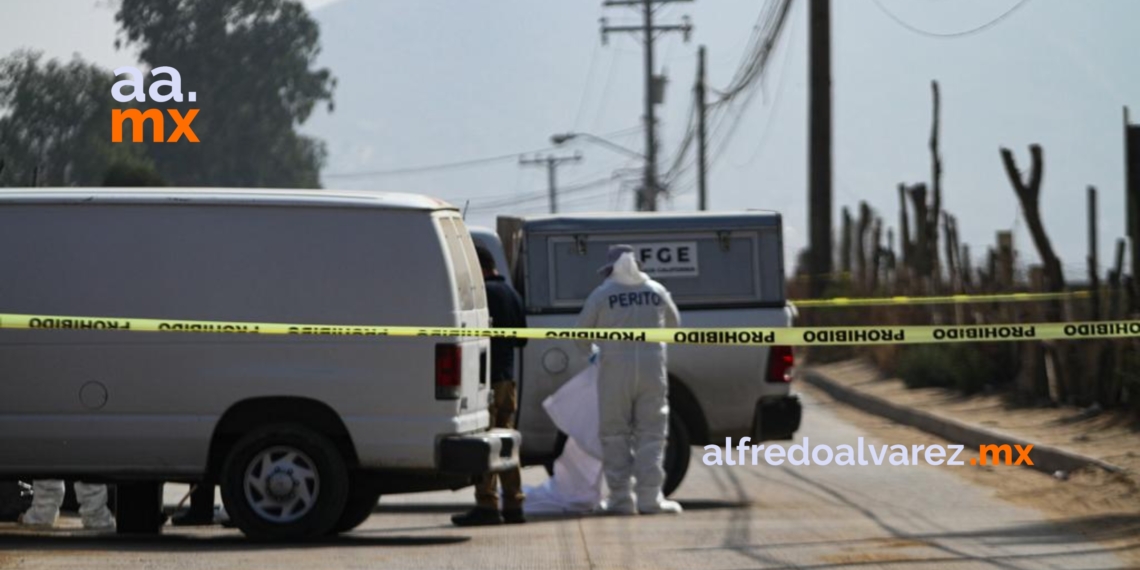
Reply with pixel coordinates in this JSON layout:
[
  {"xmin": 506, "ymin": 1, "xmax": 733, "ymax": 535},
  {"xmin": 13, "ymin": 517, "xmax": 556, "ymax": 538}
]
[{"xmin": 897, "ymin": 343, "xmax": 995, "ymax": 393}]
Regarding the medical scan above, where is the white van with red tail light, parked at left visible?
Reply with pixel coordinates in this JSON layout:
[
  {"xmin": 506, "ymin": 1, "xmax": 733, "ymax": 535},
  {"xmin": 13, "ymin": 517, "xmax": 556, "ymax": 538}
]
[{"xmin": 0, "ymin": 188, "xmax": 520, "ymax": 539}]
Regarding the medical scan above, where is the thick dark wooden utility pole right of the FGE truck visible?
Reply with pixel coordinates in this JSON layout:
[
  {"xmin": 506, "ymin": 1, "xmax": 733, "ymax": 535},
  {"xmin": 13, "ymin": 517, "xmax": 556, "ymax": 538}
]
[{"xmin": 807, "ymin": 0, "xmax": 831, "ymax": 298}]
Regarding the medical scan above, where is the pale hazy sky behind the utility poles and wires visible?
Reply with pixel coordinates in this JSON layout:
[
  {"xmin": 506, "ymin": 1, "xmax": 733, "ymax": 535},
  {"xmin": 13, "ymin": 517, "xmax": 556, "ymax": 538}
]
[{"xmin": 0, "ymin": 0, "xmax": 1140, "ymax": 276}]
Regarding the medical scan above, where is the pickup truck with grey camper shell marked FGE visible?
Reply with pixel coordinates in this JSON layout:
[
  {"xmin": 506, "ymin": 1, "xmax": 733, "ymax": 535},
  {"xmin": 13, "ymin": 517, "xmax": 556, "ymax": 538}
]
[{"xmin": 471, "ymin": 211, "xmax": 801, "ymax": 494}]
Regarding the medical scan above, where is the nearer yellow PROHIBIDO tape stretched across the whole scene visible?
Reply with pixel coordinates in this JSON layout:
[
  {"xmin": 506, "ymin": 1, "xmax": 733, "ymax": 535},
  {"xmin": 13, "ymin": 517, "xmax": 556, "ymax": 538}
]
[{"xmin": 0, "ymin": 314, "xmax": 1140, "ymax": 347}]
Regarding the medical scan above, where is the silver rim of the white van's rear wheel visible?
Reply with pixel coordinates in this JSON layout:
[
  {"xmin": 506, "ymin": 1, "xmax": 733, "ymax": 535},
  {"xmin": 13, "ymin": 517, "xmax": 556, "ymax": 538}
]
[{"xmin": 244, "ymin": 446, "xmax": 320, "ymax": 523}]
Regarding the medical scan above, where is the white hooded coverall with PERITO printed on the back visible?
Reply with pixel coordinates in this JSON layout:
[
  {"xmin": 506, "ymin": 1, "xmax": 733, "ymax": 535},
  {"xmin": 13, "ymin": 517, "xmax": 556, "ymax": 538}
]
[{"xmin": 578, "ymin": 245, "xmax": 681, "ymax": 514}]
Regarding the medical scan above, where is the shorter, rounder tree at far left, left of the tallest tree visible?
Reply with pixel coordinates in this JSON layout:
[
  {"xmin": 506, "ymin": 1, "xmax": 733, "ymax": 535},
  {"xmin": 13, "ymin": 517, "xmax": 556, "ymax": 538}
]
[{"xmin": 0, "ymin": 50, "xmax": 141, "ymax": 186}]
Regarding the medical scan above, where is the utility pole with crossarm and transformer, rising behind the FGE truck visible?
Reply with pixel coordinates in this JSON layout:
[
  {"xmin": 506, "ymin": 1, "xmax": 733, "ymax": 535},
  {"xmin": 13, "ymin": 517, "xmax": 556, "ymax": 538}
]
[{"xmin": 601, "ymin": 0, "xmax": 693, "ymax": 211}]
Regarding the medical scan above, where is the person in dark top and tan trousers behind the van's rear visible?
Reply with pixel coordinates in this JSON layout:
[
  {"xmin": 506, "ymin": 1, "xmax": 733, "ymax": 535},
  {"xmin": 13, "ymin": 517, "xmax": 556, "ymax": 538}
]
[{"xmin": 451, "ymin": 247, "xmax": 527, "ymax": 527}]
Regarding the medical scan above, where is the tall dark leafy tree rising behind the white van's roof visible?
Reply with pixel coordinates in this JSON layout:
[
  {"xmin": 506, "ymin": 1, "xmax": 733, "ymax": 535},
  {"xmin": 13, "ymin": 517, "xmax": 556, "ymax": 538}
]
[{"xmin": 115, "ymin": 0, "xmax": 335, "ymax": 187}]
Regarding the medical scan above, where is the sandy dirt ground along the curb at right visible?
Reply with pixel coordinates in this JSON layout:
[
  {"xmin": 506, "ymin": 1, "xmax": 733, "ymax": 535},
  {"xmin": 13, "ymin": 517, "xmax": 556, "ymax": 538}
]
[{"xmin": 798, "ymin": 361, "xmax": 1140, "ymax": 568}]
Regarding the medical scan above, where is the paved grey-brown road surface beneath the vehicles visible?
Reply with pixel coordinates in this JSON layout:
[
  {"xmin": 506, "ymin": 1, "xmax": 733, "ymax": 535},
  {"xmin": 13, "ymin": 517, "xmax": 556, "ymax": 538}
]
[{"xmin": 0, "ymin": 389, "xmax": 1126, "ymax": 570}]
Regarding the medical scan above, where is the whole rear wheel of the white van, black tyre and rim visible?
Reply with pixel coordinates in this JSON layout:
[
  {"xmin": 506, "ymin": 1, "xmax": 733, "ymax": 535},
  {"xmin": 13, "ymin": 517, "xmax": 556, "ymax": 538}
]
[{"xmin": 220, "ymin": 424, "xmax": 349, "ymax": 540}]
